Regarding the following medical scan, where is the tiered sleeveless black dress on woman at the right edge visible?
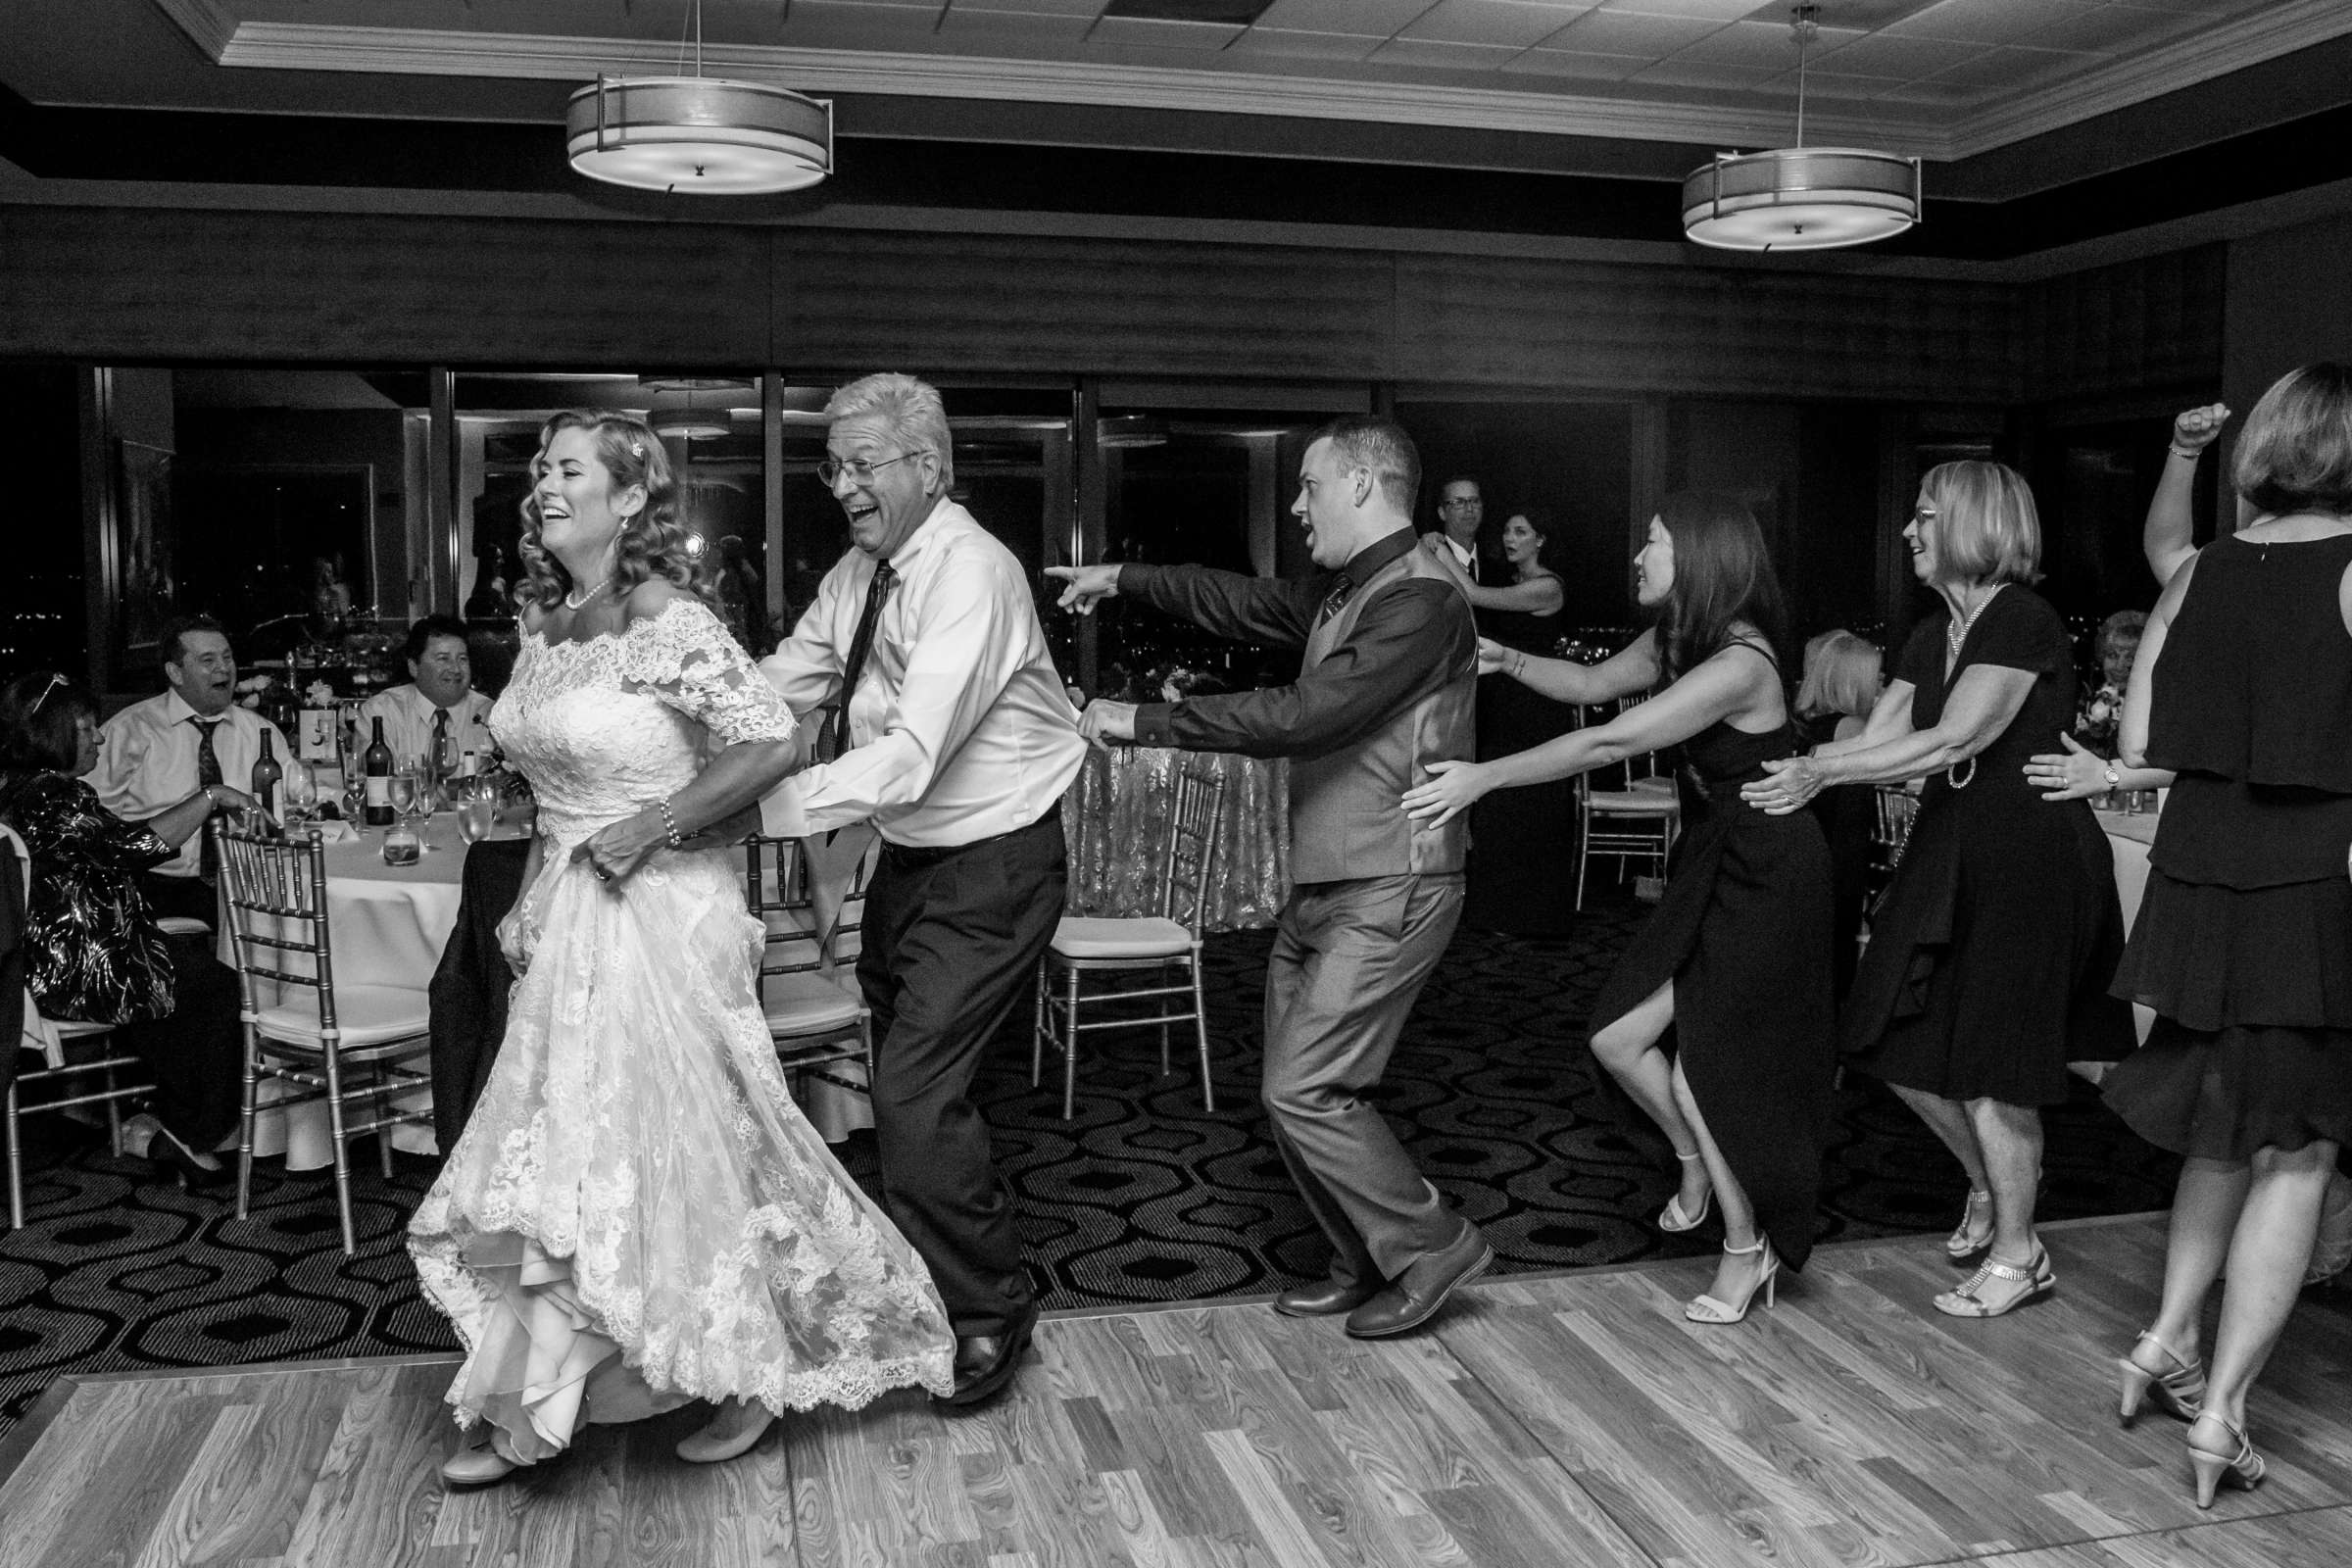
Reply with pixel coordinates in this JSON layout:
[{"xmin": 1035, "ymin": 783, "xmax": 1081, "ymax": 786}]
[{"xmin": 2105, "ymin": 536, "xmax": 2352, "ymax": 1163}]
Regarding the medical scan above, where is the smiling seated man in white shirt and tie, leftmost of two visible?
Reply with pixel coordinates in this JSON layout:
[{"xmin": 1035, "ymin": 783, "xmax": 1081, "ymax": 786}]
[{"xmin": 89, "ymin": 615, "xmax": 294, "ymax": 921}]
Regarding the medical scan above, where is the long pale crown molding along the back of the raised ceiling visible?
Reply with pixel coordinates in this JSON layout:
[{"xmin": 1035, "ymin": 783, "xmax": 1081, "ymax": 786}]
[{"xmin": 178, "ymin": 19, "xmax": 1947, "ymax": 158}]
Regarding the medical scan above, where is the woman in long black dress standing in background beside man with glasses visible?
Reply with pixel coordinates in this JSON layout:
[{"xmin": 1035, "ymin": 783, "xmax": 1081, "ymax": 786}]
[{"xmin": 1430, "ymin": 511, "xmax": 1576, "ymax": 936}]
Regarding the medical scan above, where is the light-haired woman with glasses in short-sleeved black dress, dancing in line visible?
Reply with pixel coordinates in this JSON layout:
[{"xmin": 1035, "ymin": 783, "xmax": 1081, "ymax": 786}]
[{"xmin": 1747, "ymin": 464, "xmax": 2131, "ymax": 1316}]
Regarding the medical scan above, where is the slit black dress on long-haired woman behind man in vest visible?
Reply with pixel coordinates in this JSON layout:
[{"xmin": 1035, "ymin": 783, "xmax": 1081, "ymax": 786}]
[{"xmin": 1592, "ymin": 705, "xmax": 1837, "ymax": 1269}]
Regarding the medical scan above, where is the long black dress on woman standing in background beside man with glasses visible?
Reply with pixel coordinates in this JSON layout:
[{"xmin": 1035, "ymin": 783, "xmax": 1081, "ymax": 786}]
[{"xmin": 1463, "ymin": 597, "xmax": 1576, "ymax": 936}]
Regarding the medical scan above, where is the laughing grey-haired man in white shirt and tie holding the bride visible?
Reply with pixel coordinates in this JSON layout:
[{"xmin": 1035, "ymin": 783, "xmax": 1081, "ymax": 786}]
[{"xmin": 760, "ymin": 376, "xmax": 1087, "ymax": 1403}]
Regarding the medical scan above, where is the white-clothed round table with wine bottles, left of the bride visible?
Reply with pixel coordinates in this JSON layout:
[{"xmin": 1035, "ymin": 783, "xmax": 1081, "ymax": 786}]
[{"xmin": 221, "ymin": 811, "xmax": 506, "ymax": 1171}]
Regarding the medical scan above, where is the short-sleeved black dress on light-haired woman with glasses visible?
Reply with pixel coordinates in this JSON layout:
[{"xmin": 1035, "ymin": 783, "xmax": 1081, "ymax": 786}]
[{"xmin": 1841, "ymin": 583, "xmax": 2133, "ymax": 1104}]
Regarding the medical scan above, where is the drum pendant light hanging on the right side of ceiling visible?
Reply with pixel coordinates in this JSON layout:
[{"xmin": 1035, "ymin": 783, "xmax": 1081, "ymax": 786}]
[{"xmin": 1682, "ymin": 5, "xmax": 1919, "ymax": 252}]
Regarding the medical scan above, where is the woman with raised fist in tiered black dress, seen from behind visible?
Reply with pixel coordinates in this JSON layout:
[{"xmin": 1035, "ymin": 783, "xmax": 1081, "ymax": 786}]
[{"xmin": 2105, "ymin": 365, "xmax": 2352, "ymax": 1507}]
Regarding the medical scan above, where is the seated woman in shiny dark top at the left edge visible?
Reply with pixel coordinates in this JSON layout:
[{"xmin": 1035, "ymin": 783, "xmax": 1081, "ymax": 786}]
[{"xmin": 0, "ymin": 672, "xmax": 257, "ymax": 1180}]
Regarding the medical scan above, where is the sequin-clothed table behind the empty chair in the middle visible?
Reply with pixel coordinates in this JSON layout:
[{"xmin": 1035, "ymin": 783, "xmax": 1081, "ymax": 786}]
[{"xmin": 1060, "ymin": 745, "xmax": 1292, "ymax": 931}]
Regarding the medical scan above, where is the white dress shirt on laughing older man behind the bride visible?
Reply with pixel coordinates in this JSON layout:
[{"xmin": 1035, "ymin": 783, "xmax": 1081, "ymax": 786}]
[{"xmin": 760, "ymin": 496, "xmax": 1087, "ymax": 849}]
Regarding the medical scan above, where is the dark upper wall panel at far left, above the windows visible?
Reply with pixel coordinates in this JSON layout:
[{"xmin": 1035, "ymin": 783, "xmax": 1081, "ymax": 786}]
[{"xmin": 0, "ymin": 207, "xmax": 769, "ymax": 369}]
